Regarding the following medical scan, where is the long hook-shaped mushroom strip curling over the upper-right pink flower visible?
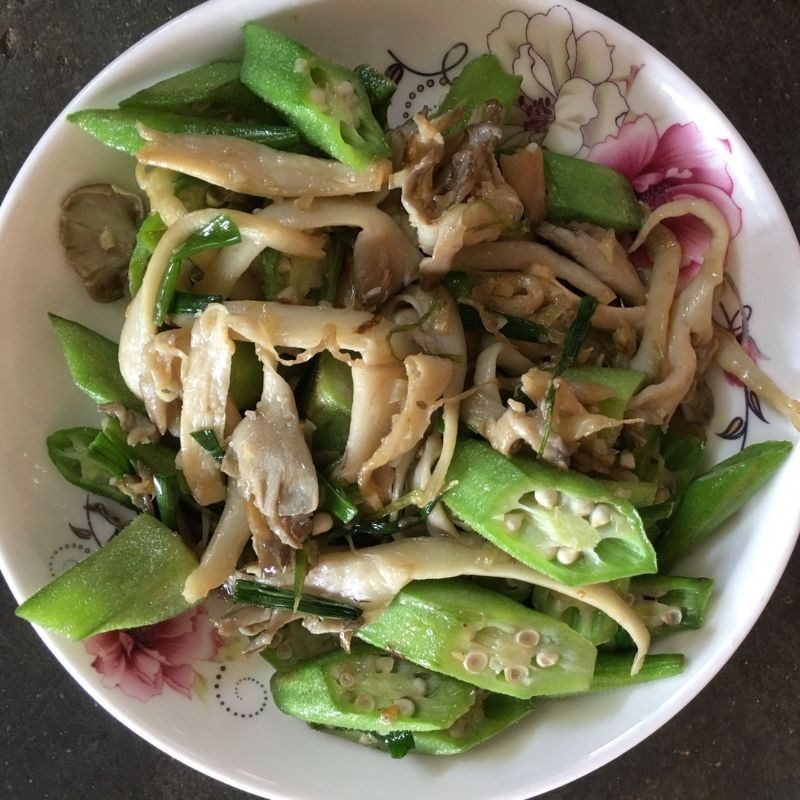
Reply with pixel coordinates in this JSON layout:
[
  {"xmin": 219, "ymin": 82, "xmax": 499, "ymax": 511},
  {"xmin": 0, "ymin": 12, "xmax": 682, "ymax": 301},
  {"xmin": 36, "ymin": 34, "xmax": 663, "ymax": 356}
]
[{"xmin": 628, "ymin": 199, "xmax": 730, "ymax": 425}]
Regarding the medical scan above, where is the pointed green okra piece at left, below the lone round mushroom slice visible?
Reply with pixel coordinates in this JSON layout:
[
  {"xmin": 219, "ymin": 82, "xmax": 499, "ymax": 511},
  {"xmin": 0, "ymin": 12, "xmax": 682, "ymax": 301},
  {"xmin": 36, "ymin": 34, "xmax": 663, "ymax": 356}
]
[{"xmin": 47, "ymin": 314, "xmax": 144, "ymax": 411}]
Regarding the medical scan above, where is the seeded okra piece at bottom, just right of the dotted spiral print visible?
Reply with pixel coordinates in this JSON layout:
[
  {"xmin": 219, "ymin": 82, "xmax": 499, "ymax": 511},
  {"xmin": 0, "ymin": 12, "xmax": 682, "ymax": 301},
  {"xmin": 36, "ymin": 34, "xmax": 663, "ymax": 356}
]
[{"xmin": 271, "ymin": 642, "xmax": 476, "ymax": 734}]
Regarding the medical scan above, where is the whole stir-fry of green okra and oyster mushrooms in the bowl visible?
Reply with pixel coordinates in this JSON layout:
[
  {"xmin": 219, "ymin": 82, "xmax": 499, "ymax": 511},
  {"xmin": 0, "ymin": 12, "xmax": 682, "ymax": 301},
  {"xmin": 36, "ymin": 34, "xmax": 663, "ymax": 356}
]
[{"xmin": 19, "ymin": 24, "xmax": 800, "ymax": 756}]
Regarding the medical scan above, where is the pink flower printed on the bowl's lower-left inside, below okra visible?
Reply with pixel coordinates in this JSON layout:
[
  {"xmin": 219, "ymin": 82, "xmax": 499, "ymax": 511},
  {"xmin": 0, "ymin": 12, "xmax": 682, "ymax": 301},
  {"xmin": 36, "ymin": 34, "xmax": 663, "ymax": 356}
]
[{"xmin": 84, "ymin": 607, "xmax": 222, "ymax": 701}]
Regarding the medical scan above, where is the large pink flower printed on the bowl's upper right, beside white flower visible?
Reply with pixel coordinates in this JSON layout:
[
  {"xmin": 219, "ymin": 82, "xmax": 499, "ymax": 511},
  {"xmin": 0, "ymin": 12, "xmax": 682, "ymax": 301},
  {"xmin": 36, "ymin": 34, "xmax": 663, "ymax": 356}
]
[{"xmin": 587, "ymin": 114, "xmax": 742, "ymax": 268}]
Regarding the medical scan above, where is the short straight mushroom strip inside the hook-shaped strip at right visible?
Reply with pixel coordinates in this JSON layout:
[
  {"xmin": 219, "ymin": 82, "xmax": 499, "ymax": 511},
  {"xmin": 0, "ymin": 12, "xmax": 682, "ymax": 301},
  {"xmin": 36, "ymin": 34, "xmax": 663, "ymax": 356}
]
[{"xmin": 630, "ymin": 225, "xmax": 681, "ymax": 380}]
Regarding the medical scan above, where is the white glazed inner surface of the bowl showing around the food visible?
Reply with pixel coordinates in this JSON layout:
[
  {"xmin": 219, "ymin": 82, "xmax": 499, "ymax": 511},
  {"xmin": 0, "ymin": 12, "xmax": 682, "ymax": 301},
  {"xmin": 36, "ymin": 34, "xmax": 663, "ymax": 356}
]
[{"xmin": 0, "ymin": 0, "xmax": 800, "ymax": 800}]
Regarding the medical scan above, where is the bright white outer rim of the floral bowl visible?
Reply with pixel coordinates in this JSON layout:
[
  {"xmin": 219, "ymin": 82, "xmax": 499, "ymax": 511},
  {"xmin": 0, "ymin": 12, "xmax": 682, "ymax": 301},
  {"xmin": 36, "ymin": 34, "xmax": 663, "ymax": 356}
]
[{"xmin": 0, "ymin": 0, "xmax": 800, "ymax": 800}]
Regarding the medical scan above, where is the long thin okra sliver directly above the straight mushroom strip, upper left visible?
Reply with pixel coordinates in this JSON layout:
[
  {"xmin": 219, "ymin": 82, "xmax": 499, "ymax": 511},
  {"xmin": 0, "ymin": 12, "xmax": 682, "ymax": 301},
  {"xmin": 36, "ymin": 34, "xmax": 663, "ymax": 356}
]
[{"xmin": 67, "ymin": 107, "xmax": 303, "ymax": 156}]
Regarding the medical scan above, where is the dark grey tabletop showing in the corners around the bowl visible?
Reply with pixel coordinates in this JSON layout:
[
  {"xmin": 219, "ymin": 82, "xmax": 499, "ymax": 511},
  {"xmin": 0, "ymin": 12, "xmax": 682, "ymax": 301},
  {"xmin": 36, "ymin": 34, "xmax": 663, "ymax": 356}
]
[{"xmin": 0, "ymin": 0, "xmax": 800, "ymax": 800}]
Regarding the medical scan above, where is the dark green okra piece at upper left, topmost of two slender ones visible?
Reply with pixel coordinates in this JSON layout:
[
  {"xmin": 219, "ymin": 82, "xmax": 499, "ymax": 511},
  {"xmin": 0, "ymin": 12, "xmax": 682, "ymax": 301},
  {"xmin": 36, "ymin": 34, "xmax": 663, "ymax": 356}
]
[{"xmin": 120, "ymin": 61, "xmax": 278, "ymax": 121}]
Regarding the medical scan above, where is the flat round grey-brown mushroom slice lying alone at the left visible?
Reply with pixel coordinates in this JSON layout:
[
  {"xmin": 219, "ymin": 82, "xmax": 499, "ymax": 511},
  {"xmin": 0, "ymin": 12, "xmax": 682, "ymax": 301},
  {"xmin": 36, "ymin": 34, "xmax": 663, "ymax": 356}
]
[{"xmin": 61, "ymin": 183, "xmax": 145, "ymax": 303}]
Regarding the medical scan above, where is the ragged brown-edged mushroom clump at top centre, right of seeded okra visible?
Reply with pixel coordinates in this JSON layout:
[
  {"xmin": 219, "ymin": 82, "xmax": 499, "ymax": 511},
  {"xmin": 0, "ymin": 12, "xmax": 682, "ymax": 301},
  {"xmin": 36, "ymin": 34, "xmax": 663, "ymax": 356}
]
[{"xmin": 392, "ymin": 108, "xmax": 523, "ymax": 281}]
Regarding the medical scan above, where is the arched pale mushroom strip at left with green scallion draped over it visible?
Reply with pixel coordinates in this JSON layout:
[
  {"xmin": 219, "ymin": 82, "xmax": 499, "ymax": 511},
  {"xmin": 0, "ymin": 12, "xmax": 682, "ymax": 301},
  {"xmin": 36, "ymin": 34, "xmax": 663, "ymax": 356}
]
[{"xmin": 119, "ymin": 208, "xmax": 323, "ymax": 404}]
